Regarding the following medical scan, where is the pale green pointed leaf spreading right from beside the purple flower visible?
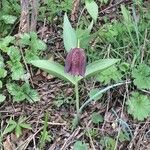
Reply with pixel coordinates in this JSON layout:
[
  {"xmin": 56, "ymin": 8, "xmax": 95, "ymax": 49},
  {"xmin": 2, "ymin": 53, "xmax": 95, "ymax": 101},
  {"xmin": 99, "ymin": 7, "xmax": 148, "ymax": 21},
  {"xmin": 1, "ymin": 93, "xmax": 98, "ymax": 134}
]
[{"xmin": 85, "ymin": 59, "xmax": 119, "ymax": 78}]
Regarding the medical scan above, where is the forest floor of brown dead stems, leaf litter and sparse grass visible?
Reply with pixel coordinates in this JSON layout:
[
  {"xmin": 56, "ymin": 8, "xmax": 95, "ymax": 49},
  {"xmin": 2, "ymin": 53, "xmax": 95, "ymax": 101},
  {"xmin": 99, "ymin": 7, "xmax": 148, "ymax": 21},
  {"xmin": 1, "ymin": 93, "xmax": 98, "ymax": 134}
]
[{"xmin": 0, "ymin": 0, "xmax": 150, "ymax": 150}]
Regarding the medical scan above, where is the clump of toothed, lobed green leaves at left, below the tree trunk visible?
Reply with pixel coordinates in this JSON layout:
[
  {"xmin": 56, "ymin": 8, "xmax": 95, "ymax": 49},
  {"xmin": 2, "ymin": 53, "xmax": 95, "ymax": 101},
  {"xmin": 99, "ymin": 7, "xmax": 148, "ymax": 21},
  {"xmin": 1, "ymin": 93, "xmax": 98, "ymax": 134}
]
[{"xmin": 0, "ymin": 32, "xmax": 46, "ymax": 103}]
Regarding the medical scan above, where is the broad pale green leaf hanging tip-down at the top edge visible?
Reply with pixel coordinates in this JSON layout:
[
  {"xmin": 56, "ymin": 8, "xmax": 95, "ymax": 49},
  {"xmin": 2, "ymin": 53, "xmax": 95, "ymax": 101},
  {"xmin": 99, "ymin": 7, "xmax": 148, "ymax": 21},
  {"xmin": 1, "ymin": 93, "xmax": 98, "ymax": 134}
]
[{"xmin": 85, "ymin": 0, "xmax": 98, "ymax": 22}]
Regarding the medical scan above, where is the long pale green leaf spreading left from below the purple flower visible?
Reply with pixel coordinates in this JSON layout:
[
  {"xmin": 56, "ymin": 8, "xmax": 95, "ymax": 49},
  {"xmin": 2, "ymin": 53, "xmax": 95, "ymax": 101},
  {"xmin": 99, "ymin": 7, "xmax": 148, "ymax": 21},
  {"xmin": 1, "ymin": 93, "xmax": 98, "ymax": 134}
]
[{"xmin": 31, "ymin": 60, "xmax": 76, "ymax": 84}]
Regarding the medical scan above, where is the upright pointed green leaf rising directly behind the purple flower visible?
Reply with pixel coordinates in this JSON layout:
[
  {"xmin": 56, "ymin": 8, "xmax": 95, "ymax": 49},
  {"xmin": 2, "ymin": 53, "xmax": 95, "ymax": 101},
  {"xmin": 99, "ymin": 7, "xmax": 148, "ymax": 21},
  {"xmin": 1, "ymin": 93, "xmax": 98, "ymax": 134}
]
[{"xmin": 63, "ymin": 13, "xmax": 77, "ymax": 52}]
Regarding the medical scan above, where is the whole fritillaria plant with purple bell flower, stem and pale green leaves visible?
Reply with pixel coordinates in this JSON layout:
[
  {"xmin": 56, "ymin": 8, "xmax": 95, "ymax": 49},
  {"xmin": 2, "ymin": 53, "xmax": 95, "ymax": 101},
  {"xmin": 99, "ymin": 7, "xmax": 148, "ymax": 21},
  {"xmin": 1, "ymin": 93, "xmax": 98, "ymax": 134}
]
[{"xmin": 31, "ymin": 14, "xmax": 120, "ymax": 127}]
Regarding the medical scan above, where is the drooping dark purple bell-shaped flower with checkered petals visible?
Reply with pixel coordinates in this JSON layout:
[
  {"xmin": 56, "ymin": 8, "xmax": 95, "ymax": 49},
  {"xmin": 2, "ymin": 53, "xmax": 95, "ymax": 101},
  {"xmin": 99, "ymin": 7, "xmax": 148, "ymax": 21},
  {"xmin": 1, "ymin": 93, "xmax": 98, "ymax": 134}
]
[{"xmin": 65, "ymin": 48, "xmax": 86, "ymax": 76}]
